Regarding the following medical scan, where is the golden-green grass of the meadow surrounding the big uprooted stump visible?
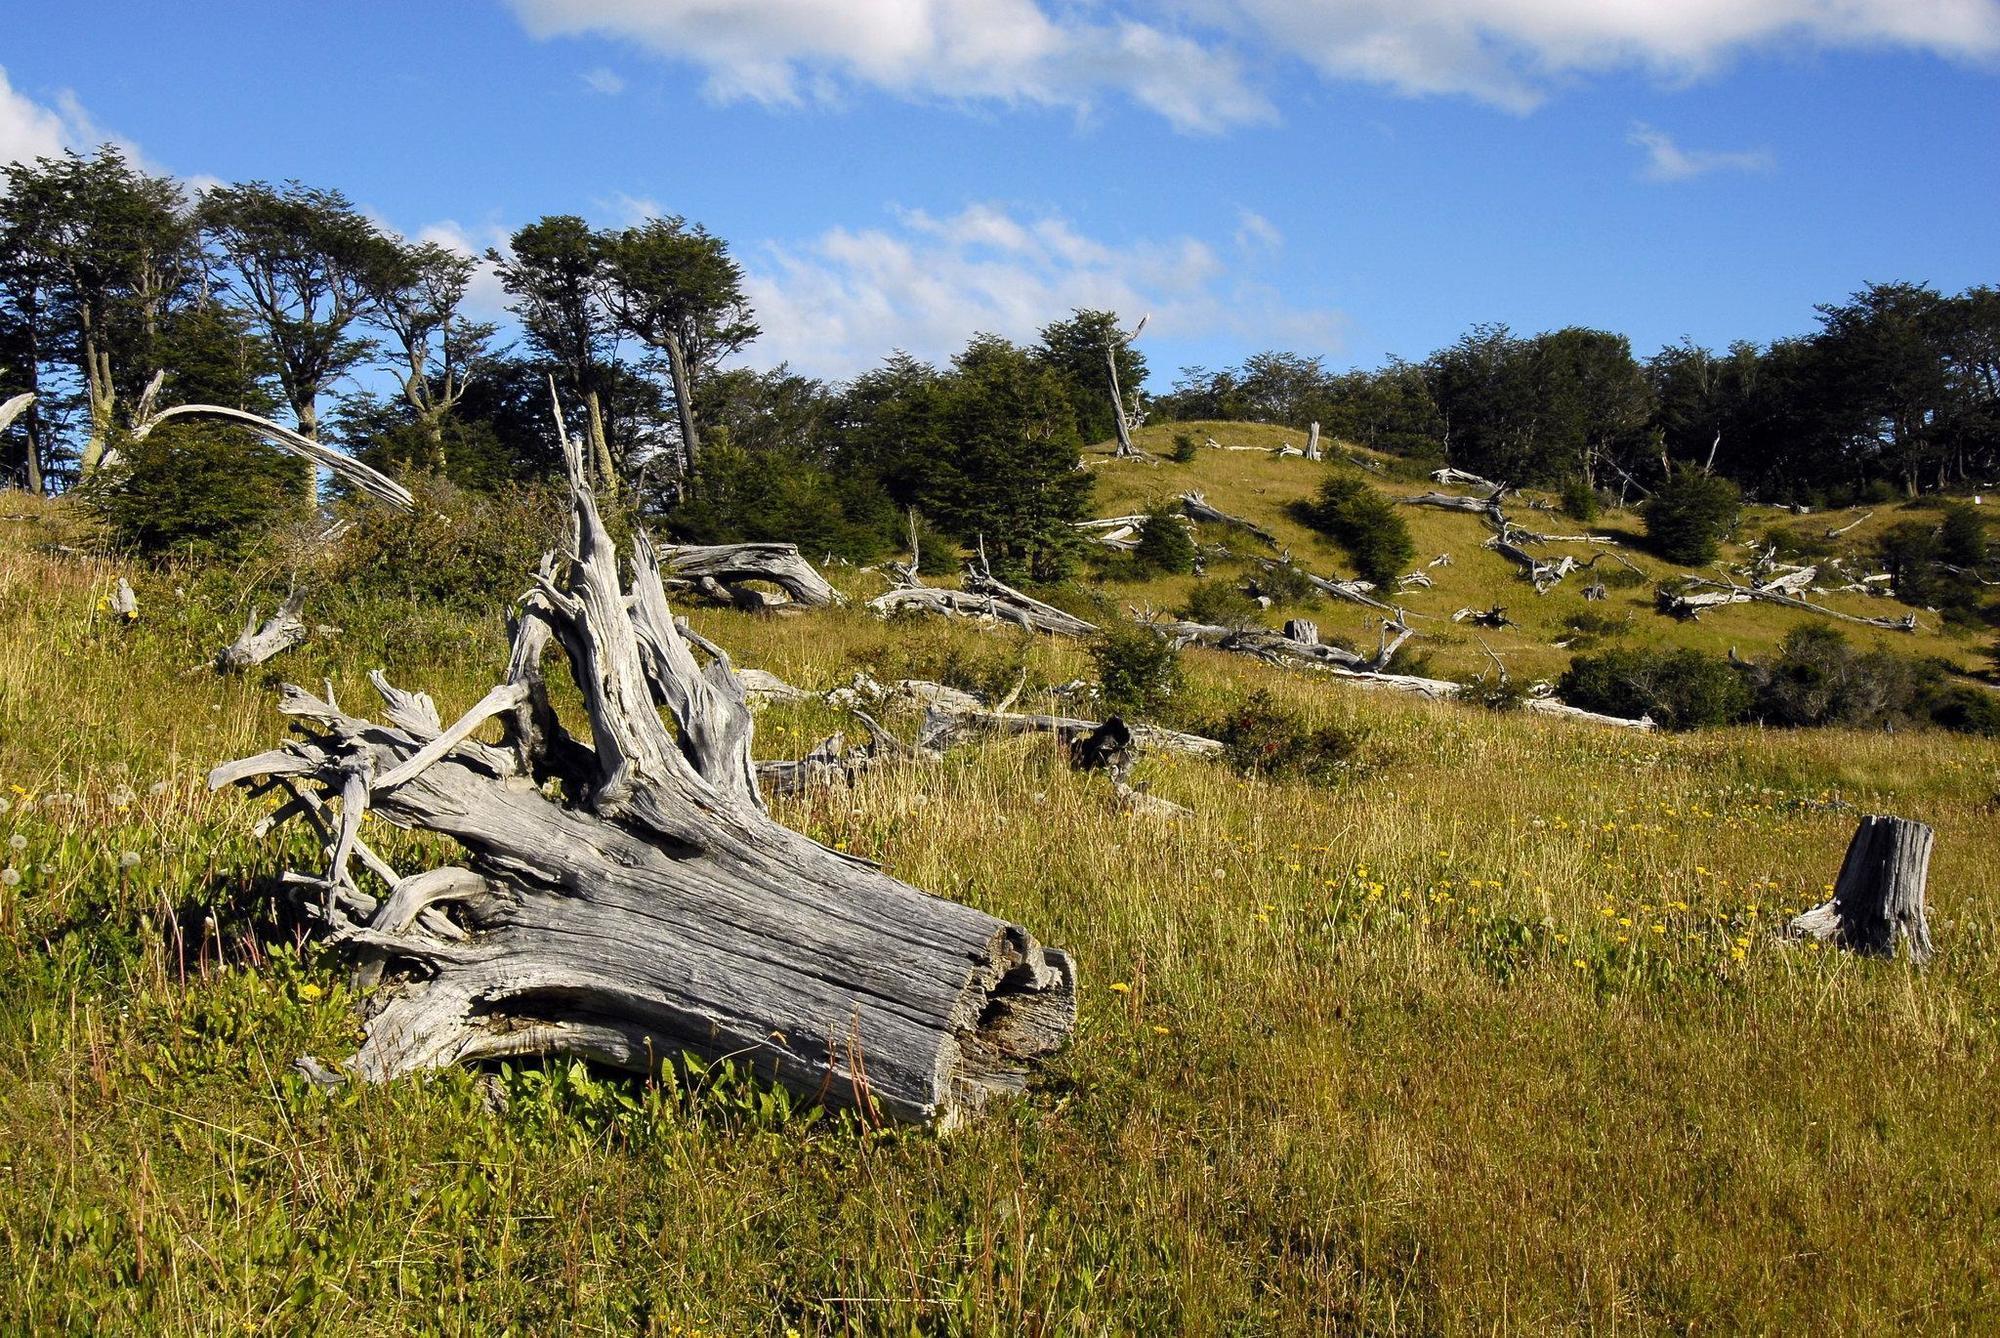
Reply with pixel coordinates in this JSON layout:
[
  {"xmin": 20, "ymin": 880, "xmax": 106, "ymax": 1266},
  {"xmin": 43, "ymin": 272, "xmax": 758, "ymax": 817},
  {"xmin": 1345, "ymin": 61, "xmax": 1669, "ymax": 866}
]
[{"xmin": 0, "ymin": 474, "xmax": 2000, "ymax": 1334}]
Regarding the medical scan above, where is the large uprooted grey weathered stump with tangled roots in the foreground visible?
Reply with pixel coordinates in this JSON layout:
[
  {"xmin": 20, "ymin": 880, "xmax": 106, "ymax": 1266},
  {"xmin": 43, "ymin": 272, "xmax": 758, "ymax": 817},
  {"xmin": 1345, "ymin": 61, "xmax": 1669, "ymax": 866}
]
[{"xmin": 210, "ymin": 434, "xmax": 1076, "ymax": 1124}]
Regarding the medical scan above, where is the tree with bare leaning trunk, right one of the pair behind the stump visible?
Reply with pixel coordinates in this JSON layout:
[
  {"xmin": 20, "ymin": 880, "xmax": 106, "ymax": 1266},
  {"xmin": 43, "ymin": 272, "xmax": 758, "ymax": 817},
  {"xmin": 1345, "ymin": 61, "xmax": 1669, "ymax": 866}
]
[{"xmin": 598, "ymin": 214, "xmax": 760, "ymax": 486}]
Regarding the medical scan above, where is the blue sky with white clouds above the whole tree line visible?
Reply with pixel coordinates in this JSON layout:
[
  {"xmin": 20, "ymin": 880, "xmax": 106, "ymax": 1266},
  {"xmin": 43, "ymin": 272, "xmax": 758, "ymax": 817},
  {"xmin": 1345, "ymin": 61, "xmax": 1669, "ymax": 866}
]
[{"xmin": 0, "ymin": 0, "xmax": 2000, "ymax": 388}]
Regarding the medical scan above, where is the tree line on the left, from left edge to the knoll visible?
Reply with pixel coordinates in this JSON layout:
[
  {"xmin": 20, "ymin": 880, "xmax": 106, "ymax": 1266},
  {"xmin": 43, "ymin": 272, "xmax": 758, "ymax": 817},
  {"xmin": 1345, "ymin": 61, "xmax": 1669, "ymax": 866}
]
[{"xmin": 0, "ymin": 148, "xmax": 1146, "ymax": 576}]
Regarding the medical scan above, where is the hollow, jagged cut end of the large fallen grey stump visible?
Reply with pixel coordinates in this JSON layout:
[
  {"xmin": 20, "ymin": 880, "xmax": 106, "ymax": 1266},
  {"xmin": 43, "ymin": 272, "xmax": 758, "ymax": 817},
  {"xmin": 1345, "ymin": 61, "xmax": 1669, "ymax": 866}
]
[{"xmin": 936, "ymin": 926, "xmax": 1076, "ymax": 1130}]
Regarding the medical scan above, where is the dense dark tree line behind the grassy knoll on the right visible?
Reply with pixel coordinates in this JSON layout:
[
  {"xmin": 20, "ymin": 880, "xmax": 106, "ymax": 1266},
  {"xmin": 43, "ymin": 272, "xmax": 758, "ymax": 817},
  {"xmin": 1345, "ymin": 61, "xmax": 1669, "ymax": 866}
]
[{"xmin": 1152, "ymin": 284, "xmax": 2000, "ymax": 502}]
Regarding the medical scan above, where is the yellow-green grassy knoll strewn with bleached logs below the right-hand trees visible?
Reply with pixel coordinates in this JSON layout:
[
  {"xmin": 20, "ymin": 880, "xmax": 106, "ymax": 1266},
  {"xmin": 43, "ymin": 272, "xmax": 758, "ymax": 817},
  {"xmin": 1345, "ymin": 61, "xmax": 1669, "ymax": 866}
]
[{"xmin": 1086, "ymin": 422, "xmax": 1990, "ymax": 676}]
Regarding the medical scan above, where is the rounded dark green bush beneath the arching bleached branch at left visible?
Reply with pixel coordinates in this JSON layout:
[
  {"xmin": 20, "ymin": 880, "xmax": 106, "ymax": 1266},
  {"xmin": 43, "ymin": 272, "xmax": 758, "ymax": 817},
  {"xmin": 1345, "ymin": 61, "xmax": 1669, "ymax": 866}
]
[{"xmin": 86, "ymin": 422, "xmax": 304, "ymax": 560}]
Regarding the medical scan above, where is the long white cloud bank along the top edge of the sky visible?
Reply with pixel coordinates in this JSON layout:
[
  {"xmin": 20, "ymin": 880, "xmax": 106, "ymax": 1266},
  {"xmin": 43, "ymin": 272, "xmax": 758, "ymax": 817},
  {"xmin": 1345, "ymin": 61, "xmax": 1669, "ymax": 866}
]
[{"xmin": 508, "ymin": 0, "xmax": 2000, "ymax": 130}]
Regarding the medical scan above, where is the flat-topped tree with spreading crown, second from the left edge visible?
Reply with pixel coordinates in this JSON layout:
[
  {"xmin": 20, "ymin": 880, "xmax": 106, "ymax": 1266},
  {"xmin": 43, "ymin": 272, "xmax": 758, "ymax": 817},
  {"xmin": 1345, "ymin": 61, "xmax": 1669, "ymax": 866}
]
[{"xmin": 200, "ymin": 182, "xmax": 394, "ymax": 506}]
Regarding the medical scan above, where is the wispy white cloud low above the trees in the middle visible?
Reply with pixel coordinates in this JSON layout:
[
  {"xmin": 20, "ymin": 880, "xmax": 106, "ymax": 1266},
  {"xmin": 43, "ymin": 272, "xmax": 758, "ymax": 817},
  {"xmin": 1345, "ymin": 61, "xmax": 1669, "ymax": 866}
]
[{"xmin": 744, "ymin": 204, "xmax": 1342, "ymax": 378}]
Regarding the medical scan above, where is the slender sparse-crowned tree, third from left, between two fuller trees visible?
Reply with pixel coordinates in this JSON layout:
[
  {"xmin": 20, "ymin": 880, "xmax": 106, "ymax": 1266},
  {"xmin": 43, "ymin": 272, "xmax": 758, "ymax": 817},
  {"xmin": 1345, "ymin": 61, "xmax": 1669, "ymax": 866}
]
[{"xmin": 368, "ymin": 242, "xmax": 494, "ymax": 470}]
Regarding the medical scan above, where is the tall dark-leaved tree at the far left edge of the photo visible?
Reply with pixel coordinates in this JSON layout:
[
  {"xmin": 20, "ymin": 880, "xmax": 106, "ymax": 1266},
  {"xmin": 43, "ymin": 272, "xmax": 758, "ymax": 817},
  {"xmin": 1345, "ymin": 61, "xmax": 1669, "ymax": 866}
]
[{"xmin": 0, "ymin": 144, "xmax": 196, "ymax": 476}]
